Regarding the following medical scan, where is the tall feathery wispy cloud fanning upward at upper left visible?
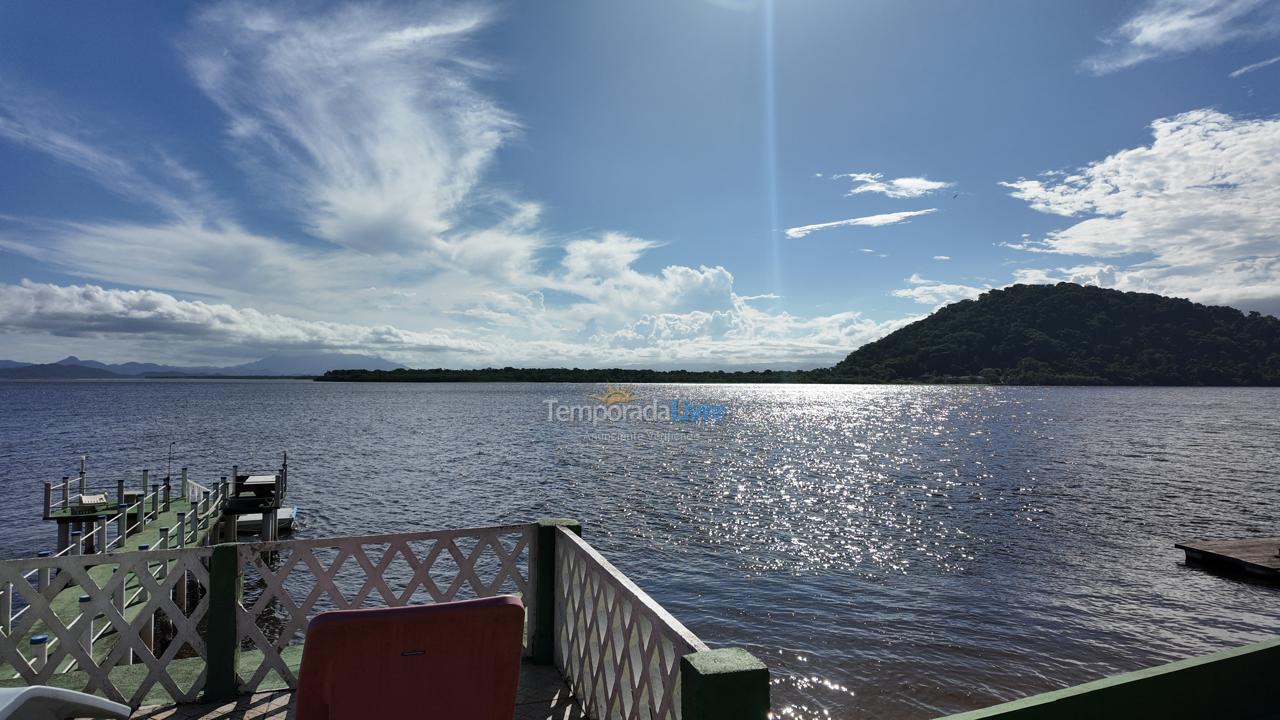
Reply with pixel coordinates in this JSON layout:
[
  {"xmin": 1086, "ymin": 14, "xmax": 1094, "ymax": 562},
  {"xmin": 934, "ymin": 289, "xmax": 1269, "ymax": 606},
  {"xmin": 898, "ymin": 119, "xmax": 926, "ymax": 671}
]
[{"xmin": 184, "ymin": 3, "xmax": 517, "ymax": 254}]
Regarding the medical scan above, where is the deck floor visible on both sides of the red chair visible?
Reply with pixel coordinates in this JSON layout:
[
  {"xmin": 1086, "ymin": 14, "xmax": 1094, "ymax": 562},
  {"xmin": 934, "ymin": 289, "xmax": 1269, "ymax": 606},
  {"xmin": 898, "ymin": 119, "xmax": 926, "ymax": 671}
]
[{"xmin": 133, "ymin": 661, "xmax": 586, "ymax": 720}]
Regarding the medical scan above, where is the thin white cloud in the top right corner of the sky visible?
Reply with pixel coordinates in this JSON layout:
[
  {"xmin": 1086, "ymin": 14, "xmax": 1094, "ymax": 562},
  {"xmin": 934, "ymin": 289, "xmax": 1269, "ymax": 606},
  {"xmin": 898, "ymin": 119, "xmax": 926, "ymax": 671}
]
[{"xmin": 1084, "ymin": 0, "xmax": 1280, "ymax": 74}]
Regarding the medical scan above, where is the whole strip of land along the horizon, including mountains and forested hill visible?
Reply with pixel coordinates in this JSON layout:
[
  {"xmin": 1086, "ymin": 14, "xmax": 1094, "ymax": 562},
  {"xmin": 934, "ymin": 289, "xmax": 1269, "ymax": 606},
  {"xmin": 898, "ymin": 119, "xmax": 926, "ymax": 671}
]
[{"xmin": 0, "ymin": 283, "xmax": 1280, "ymax": 387}]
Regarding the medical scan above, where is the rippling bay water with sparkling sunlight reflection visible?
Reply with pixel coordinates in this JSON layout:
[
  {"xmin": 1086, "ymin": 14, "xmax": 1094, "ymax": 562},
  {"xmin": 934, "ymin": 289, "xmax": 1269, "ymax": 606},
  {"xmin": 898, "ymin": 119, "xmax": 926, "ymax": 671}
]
[{"xmin": 0, "ymin": 380, "xmax": 1280, "ymax": 719}]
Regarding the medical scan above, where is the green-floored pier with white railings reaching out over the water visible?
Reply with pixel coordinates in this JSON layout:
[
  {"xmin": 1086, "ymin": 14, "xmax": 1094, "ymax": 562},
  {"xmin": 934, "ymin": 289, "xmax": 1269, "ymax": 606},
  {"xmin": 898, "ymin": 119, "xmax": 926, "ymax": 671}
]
[{"xmin": 0, "ymin": 456, "xmax": 288, "ymax": 683}]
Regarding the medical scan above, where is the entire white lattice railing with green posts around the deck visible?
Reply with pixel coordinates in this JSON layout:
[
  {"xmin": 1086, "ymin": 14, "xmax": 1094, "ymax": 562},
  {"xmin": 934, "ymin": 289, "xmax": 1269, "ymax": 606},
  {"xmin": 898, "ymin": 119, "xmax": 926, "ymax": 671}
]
[{"xmin": 0, "ymin": 517, "xmax": 769, "ymax": 720}]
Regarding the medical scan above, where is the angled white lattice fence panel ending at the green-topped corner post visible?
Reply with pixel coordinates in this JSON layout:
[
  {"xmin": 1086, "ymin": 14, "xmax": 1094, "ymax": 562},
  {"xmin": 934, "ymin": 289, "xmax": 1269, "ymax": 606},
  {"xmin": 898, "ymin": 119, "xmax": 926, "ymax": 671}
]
[{"xmin": 554, "ymin": 528, "xmax": 708, "ymax": 720}]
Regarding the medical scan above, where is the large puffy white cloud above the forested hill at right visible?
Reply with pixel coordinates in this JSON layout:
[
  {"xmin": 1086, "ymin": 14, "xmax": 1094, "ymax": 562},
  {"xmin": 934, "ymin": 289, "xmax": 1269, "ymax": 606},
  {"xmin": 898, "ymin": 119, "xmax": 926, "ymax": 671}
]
[{"xmin": 1002, "ymin": 109, "xmax": 1280, "ymax": 307}]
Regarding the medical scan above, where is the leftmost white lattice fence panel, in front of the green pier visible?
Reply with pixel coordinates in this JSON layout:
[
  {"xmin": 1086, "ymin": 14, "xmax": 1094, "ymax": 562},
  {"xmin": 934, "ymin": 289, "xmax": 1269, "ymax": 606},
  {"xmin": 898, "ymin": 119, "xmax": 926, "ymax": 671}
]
[{"xmin": 0, "ymin": 548, "xmax": 210, "ymax": 706}]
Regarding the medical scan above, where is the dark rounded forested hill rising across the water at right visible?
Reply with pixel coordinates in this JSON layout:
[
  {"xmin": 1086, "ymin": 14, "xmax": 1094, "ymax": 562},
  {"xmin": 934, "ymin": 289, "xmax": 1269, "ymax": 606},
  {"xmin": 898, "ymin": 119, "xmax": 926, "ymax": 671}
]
[{"xmin": 831, "ymin": 283, "xmax": 1280, "ymax": 386}]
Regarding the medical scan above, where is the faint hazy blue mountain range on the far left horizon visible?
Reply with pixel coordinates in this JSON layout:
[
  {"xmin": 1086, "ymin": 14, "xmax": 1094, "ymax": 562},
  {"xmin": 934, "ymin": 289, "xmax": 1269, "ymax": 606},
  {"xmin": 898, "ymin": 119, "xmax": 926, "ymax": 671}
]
[{"xmin": 0, "ymin": 352, "xmax": 401, "ymax": 379}]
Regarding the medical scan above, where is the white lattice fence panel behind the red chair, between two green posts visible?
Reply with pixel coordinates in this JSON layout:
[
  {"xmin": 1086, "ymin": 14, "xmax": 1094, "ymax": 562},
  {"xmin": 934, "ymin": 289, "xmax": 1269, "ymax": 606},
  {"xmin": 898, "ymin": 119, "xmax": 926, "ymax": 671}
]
[{"xmin": 237, "ymin": 524, "xmax": 536, "ymax": 692}]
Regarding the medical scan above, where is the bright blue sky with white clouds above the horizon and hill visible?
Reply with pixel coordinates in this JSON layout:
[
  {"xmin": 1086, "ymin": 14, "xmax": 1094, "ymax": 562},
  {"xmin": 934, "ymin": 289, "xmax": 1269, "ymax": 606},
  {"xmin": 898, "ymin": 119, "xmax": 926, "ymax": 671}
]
[{"xmin": 0, "ymin": 0, "xmax": 1280, "ymax": 369}]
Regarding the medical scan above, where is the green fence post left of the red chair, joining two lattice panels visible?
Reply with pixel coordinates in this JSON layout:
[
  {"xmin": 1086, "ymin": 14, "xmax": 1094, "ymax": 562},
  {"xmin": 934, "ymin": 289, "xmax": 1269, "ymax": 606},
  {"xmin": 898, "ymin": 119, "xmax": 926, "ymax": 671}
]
[{"xmin": 204, "ymin": 543, "xmax": 244, "ymax": 702}]
